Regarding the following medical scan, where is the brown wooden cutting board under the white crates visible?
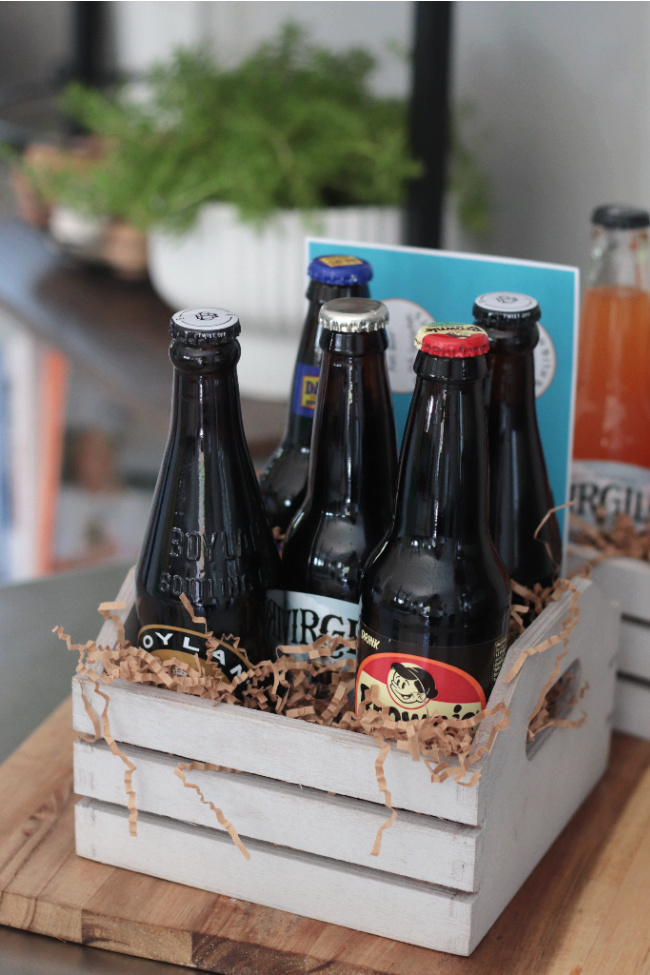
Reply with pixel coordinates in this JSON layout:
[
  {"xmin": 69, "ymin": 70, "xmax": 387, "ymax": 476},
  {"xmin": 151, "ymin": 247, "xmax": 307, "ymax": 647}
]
[{"xmin": 0, "ymin": 702, "xmax": 650, "ymax": 975}]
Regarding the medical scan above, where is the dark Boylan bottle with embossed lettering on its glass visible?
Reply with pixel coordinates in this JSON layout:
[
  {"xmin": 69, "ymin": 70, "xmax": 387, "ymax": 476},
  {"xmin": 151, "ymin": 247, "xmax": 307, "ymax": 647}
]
[{"xmin": 136, "ymin": 308, "xmax": 280, "ymax": 677}]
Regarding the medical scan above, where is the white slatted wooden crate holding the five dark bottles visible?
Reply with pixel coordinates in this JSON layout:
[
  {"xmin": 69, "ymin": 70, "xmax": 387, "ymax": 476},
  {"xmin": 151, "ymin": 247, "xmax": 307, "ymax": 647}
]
[{"xmin": 73, "ymin": 581, "xmax": 618, "ymax": 955}]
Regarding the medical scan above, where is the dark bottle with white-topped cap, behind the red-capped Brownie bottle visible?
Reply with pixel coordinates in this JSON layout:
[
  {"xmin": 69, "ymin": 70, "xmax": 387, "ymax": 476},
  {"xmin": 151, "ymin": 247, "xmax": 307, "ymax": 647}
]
[{"xmin": 473, "ymin": 291, "xmax": 562, "ymax": 587}]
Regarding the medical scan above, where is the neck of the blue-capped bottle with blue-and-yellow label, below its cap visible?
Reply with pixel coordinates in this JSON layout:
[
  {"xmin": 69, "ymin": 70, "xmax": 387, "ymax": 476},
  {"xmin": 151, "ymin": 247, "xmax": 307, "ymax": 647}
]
[{"xmin": 283, "ymin": 281, "xmax": 370, "ymax": 450}]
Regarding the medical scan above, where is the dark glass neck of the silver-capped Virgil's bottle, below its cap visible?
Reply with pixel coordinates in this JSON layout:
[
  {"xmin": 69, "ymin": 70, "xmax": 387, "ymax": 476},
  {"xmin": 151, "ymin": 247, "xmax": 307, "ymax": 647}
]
[{"xmin": 305, "ymin": 329, "xmax": 394, "ymax": 515}]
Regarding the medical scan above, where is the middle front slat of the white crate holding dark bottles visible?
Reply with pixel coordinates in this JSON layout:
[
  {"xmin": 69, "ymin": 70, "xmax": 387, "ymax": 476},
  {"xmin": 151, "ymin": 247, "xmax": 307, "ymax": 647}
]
[{"xmin": 74, "ymin": 740, "xmax": 481, "ymax": 891}]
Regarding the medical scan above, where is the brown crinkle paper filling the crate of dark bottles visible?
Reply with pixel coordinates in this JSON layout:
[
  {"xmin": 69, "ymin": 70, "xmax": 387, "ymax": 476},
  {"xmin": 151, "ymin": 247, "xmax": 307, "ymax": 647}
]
[{"xmin": 54, "ymin": 579, "xmax": 584, "ymax": 859}]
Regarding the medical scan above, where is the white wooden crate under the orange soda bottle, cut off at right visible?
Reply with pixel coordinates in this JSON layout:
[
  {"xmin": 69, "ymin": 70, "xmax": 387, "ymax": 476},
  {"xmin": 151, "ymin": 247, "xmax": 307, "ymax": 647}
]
[{"xmin": 568, "ymin": 546, "xmax": 650, "ymax": 741}]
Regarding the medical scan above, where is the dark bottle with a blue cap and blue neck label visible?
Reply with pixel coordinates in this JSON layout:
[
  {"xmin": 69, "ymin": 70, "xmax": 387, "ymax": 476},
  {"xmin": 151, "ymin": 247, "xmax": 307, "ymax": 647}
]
[{"xmin": 260, "ymin": 254, "xmax": 372, "ymax": 532}]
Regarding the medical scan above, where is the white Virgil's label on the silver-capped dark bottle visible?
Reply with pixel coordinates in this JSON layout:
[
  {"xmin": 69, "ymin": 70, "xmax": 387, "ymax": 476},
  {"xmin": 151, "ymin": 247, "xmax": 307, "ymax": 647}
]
[{"xmin": 267, "ymin": 590, "xmax": 359, "ymax": 660}]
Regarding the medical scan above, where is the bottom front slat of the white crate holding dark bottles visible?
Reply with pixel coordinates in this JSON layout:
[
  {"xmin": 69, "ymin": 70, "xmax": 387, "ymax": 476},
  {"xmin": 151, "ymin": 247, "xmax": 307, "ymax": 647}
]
[{"xmin": 75, "ymin": 799, "xmax": 476, "ymax": 955}]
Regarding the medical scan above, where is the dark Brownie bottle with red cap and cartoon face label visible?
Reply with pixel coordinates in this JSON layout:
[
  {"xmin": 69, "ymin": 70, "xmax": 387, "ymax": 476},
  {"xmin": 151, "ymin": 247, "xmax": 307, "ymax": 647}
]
[{"xmin": 356, "ymin": 323, "xmax": 510, "ymax": 721}]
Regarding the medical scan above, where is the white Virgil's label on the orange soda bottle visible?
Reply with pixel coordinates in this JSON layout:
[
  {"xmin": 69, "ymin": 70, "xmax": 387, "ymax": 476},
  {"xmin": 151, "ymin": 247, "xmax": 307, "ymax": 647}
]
[{"xmin": 571, "ymin": 460, "xmax": 650, "ymax": 528}]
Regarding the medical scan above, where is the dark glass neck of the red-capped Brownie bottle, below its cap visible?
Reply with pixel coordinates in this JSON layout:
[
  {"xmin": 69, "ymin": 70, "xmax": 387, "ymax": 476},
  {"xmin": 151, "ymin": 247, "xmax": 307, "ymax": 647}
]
[{"xmin": 392, "ymin": 352, "xmax": 488, "ymax": 544}]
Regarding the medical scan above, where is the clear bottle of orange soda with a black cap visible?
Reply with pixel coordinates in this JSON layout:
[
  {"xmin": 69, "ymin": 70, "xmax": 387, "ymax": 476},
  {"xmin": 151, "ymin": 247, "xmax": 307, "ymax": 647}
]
[{"xmin": 571, "ymin": 205, "xmax": 650, "ymax": 528}]
